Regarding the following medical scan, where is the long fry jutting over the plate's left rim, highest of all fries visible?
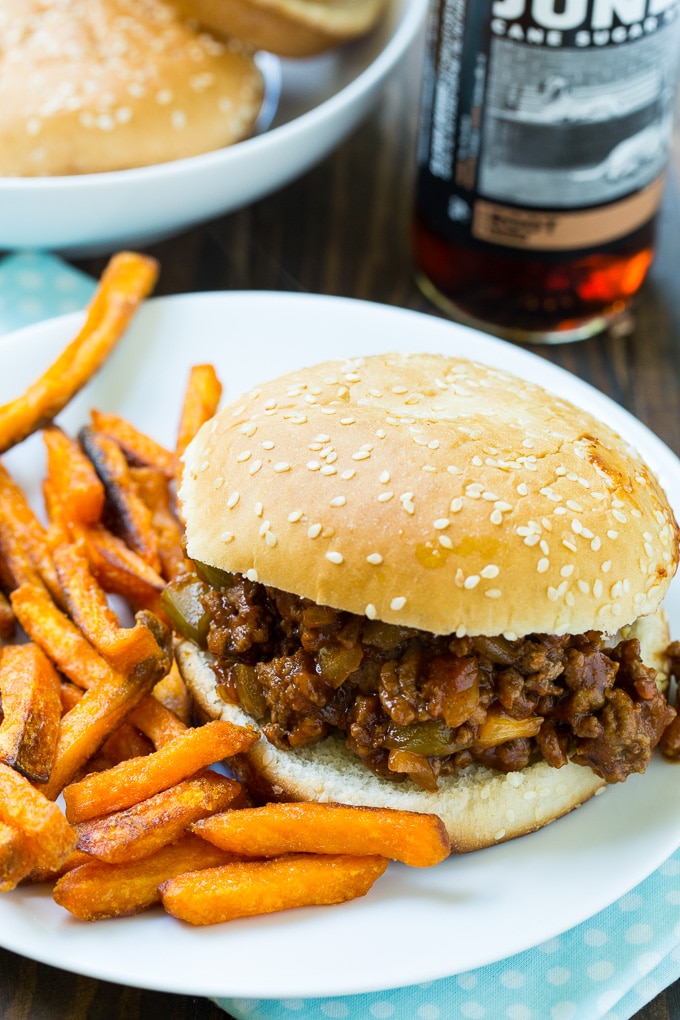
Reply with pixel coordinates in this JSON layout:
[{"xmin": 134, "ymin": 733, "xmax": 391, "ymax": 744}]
[{"xmin": 0, "ymin": 252, "xmax": 158, "ymax": 453}]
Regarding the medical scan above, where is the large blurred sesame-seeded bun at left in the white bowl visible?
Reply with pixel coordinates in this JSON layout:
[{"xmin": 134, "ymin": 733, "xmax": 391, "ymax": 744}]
[{"xmin": 0, "ymin": 0, "xmax": 263, "ymax": 176}]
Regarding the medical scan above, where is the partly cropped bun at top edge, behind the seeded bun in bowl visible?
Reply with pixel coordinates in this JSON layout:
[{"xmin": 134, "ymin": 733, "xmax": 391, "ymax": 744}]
[{"xmin": 165, "ymin": 0, "xmax": 386, "ymax": 57}]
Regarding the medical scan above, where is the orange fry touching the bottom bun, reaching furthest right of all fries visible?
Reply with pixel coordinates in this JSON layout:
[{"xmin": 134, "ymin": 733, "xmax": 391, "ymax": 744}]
[{"xmin": 192, "ymin": 803, "xmax": 451, "ymax": 868}]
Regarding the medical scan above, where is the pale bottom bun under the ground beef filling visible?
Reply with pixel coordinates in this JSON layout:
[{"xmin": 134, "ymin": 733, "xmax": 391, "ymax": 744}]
[{"xmin": 176, "ymin": 641, "xmax": 652, "ymax": 853}]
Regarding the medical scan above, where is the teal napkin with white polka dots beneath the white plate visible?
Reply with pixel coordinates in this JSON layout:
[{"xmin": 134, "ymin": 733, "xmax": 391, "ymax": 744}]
[{"xmin": 0, "ymin": 253, "xmax": 680, "ymax": 1020}]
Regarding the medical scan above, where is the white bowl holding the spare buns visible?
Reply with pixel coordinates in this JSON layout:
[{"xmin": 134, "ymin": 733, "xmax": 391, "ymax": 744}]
[{"xmin": 0, "ymin": 0, "xmax": 426, "ymax": 254}]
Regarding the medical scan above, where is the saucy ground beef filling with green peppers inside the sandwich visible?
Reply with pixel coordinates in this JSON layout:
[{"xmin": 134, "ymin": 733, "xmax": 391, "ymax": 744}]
[{"xmin": 202, "ymin": 575, "xmax": 675, "ymax": 789}]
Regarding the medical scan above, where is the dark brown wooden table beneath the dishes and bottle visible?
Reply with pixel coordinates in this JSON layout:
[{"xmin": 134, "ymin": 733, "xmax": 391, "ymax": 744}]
[{"xmin": 0, "ymin": 27, "xmax": 680, "ymax": 1020}]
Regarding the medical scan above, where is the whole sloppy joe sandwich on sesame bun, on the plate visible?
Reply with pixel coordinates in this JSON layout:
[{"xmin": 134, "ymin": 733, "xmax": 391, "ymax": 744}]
[{"xmin": 167, "ymin": 354, "xmax": 678, "ymax": 852}]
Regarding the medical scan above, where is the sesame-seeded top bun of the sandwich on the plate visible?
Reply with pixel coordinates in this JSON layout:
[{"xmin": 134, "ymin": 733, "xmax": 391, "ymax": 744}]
[{"xmin": 179, "ymin": 354, "xmax": 678, "ymax": 638}]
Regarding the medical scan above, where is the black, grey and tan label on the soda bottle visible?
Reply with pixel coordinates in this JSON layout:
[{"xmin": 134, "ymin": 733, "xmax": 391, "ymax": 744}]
[{"xmin": 418, "ymin": 0, "xmax": 680, "ymax": 251}]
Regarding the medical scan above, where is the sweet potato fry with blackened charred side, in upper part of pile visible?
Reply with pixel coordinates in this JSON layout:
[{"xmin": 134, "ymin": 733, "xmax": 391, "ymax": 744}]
[{"xmin": 79, "ymin": 426, "xmax": 160, "ymax": 572}]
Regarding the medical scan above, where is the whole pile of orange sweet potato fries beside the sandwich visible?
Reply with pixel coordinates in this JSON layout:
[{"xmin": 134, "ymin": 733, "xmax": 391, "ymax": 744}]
[{"xmin": 0, "ymin": 252, "xmax": 451, "ymax": 924}]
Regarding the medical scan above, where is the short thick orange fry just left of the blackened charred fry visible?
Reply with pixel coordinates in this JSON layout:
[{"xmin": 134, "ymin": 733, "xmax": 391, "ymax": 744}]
[{"xmin": 43, "ymin": 425, "xmax": 104, "ymax": 529}]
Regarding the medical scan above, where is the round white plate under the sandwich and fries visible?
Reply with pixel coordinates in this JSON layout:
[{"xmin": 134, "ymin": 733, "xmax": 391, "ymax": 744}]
[{"xmin": 0, "ymin": 293, "xmax": 680, "ymax": 998}]
